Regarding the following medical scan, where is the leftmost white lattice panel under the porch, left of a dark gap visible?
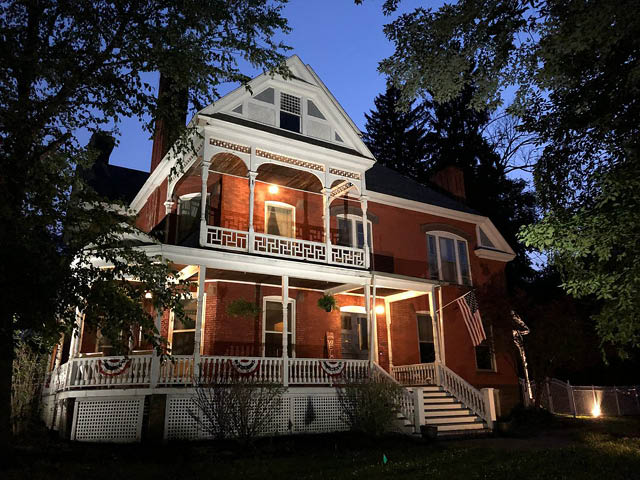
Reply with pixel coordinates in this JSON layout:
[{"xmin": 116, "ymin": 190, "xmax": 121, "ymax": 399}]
[{"xmin": 74, "ymin": 397, "xmax": 144, "ymax": 442}]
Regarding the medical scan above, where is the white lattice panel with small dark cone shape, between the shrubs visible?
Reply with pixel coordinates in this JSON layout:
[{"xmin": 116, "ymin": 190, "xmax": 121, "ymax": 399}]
[{"xmin": 291, "ymin": 395, "xmax": 349, "ymax": 433}]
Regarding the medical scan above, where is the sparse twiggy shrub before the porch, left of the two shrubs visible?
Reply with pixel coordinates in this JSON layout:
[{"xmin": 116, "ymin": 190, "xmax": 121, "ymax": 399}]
[{"xmin": 190, "ymin": 377, "xmax": 286, "ymax": 445}]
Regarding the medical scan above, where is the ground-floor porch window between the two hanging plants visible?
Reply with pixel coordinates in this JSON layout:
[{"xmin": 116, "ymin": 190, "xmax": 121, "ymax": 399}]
[{"xmin": 262, "ymin": 297, "xmax": 295, "ymax": 357}]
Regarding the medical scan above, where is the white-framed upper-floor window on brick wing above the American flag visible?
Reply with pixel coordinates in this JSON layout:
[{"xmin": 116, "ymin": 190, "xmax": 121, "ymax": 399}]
[{"xmin": 427, "ymin": 233, "xmax": 471, "ymax": 285}]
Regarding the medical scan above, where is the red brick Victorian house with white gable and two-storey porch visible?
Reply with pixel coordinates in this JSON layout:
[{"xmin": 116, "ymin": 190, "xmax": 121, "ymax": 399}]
[{"xmin": 44, "ymin": 56, "xmax": 519, "ymax": 441}]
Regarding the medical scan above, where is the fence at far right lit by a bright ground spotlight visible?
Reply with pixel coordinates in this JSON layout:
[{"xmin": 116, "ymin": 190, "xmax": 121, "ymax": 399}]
[{"xmin": 520, "ymin": 378, "xmax": 640, "ymax": 416}]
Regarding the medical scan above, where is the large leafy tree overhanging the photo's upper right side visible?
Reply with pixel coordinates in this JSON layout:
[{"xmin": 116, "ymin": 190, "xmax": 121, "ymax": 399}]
[{"xmin": 372, "ymin": 0, "xmax": 640, "ymax": 351}]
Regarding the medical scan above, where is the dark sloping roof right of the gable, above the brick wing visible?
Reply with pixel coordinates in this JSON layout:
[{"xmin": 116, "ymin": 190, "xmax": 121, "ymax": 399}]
[{"xmin": 365, "ymin": 163, "xmax": 481, "ymax": 215}]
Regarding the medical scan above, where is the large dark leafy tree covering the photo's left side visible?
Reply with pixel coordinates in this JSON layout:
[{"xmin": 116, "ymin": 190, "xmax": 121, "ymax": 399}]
[{"xmin": 0, "ymin": 0, "xmax": 288, "ymax": 445}]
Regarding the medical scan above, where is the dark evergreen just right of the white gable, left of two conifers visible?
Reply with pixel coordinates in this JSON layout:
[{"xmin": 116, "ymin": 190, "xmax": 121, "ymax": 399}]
[{"xmin": 363, "ymin": 85, "xmax": 426, "ymax": 178}]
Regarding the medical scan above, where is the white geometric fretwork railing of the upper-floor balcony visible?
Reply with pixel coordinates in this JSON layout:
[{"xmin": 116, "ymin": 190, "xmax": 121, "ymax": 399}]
[{"xmin": 204, "ymin": 225, "xmax": 368, "ymax": 268}]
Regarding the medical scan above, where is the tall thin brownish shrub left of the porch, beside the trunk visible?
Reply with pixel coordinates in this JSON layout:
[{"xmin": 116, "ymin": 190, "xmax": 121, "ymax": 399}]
[{"xmin": 11, "ymin": 341, "xmax": 47, "ymax": 435}]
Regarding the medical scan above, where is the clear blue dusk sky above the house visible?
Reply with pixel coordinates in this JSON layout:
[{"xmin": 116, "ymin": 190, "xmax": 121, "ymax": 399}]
[{"xmin": 111, "ymin": 0, "xmax": 443, "ymax": 170}]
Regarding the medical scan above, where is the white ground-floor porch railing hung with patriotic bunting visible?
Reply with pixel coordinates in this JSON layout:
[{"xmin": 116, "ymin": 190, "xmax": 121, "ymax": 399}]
[{"xmin": 45, "ymin": 355, "xmax": 369, "ymax": 394}]
